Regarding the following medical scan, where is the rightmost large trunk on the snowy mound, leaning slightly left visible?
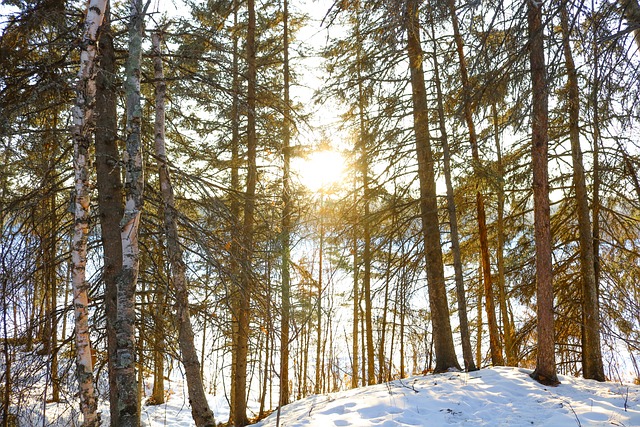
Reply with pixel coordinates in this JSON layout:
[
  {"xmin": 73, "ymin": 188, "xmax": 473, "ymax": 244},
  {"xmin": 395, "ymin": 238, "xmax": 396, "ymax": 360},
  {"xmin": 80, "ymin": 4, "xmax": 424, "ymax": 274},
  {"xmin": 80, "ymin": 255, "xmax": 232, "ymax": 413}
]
[{"xmin": 560, "ymin": 4, "xmax": 606, "ymax": 381}]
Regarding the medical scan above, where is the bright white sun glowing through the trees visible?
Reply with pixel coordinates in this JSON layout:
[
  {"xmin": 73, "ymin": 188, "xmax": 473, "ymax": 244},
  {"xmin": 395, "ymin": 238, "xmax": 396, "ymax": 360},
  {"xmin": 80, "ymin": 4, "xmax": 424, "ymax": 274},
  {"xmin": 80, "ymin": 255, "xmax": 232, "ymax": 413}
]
[{"xmin": 296, "ymin": 150, "xmax": 345, "ymax": 192}]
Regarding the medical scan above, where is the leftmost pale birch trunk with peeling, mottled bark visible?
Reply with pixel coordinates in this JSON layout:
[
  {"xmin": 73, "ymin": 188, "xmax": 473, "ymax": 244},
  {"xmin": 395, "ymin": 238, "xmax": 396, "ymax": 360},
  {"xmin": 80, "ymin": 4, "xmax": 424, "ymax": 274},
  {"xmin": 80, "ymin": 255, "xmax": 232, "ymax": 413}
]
[{"xmin": 71, "ymin": 0, "xmax": 106, "ymax": 427}]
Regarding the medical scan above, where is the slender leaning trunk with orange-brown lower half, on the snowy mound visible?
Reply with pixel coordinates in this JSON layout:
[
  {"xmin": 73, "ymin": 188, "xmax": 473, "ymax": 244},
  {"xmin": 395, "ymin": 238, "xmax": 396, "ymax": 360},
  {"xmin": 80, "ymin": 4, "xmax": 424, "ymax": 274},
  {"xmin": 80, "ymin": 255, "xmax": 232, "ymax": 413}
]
[{"xmin": 448, "ymin": 0, "xmax": 504, "ymax": 365}]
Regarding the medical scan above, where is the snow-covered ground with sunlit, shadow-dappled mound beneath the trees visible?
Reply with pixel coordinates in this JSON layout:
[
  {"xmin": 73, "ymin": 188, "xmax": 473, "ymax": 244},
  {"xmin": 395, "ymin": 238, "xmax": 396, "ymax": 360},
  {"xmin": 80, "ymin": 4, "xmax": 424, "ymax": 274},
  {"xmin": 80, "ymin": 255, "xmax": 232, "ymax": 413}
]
[{"xmin": 143, "ymin": 367, "xmax": 640, "ymax": 427}]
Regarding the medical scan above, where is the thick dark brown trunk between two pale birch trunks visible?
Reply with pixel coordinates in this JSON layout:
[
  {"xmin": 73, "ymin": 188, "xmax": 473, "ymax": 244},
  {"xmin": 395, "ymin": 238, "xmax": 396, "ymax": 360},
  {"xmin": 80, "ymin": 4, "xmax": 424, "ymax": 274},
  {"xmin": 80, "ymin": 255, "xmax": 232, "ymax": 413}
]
[{"xmin": 95, "ymin": 7, "xmax": 123, "ymax": 427}]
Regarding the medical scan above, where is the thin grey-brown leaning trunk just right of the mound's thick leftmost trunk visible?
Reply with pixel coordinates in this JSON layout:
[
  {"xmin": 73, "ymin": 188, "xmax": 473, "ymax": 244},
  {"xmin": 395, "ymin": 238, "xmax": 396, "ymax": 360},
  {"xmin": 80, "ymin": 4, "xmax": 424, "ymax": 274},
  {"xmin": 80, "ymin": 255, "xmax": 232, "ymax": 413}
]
[{"xmin": 431, "ymin": 15, "xmax": 478, "ymax": 372}]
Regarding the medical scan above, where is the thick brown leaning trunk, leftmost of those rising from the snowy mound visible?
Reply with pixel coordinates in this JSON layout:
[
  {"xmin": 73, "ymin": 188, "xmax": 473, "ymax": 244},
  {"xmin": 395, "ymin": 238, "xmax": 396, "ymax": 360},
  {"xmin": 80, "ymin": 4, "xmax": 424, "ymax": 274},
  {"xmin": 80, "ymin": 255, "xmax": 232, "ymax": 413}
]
[{"xmin": 407, "ymin": 0, "xmax": 460, "ymax": 372}]
